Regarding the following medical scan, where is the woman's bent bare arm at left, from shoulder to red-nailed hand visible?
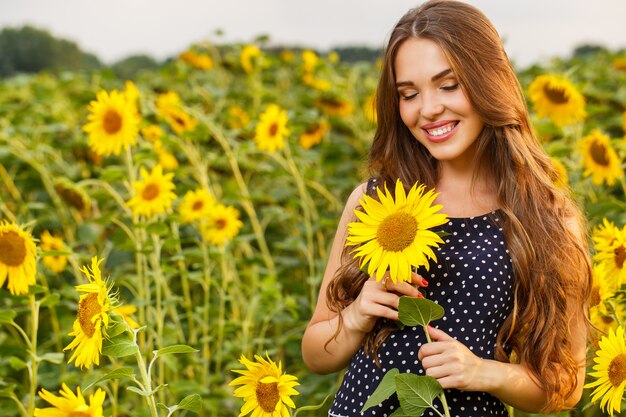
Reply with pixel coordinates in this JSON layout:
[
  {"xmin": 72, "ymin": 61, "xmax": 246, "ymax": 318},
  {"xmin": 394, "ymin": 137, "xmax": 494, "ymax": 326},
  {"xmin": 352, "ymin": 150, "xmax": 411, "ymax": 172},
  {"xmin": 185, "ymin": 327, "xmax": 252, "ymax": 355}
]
[{"xmin": 302, "ymin": 184, "xmax": 421, "ymax": 374}]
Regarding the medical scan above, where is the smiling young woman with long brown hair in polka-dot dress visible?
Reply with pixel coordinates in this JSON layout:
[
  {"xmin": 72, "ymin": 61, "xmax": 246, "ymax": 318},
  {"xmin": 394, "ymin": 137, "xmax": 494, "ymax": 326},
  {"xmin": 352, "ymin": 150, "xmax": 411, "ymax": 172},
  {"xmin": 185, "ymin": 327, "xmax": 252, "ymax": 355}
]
[{"xmin": 302, "ymin": 0, "xmax": 591, "ymax": 416}]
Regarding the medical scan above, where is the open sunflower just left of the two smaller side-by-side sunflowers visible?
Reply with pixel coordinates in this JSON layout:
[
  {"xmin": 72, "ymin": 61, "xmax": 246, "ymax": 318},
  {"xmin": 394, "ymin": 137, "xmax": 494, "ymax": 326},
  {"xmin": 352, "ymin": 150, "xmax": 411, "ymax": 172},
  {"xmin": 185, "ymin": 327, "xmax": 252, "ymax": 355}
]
[{"xmin": 126, "ymin": 165, "xmax": 176, "ymax": 217}]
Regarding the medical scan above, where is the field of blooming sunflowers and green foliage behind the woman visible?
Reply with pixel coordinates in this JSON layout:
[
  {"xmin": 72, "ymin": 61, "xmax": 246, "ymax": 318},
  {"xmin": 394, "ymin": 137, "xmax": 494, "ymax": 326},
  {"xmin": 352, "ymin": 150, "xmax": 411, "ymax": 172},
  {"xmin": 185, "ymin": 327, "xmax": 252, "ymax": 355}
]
[{"xmin": 0, "ymin": 43, "xmax": 626, "ymax": 417}]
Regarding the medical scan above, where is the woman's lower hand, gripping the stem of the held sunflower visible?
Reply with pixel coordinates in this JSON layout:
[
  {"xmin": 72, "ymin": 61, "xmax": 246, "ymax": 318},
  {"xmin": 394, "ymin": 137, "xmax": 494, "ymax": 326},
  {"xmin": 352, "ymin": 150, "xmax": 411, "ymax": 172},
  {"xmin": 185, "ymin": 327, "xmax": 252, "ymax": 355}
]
[{"xmin": 417, "ymin": 325, "xmax": 484, "ymax": 391}]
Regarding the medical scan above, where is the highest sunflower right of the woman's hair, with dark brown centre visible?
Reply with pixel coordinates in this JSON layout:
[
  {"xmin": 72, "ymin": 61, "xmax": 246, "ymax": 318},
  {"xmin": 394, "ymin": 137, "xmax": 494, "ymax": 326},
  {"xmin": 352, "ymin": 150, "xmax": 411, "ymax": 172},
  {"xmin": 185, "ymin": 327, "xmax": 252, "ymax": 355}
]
[{"xmin": 528, "ymin": 74, "xmax": 587, "ymax": 127}]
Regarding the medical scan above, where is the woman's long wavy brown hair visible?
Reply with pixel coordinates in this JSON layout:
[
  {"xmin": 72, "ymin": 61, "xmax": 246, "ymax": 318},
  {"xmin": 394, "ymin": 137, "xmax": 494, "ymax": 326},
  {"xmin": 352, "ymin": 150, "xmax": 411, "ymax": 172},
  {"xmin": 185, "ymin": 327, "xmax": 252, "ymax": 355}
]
[{"xmin": 327, "ymin": 0, "xmax": 591, "ymax": 410}]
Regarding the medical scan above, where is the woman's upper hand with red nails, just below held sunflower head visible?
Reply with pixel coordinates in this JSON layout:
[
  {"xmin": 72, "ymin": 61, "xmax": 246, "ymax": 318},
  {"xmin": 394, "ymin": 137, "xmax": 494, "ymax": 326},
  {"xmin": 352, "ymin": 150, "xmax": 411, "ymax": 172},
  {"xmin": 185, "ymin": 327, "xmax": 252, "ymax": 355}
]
[{"xmin": 343, "ymin": 272, "xmax": 428, "ymax": 333}]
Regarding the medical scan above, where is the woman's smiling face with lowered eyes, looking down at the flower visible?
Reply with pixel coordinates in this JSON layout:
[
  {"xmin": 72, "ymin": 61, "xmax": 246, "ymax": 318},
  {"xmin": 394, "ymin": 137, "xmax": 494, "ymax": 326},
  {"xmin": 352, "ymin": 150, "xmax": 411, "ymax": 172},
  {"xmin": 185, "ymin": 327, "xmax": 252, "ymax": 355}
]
[{"xmin": 395, "ymin": 38, "xmax": 484, "ymax": 168}]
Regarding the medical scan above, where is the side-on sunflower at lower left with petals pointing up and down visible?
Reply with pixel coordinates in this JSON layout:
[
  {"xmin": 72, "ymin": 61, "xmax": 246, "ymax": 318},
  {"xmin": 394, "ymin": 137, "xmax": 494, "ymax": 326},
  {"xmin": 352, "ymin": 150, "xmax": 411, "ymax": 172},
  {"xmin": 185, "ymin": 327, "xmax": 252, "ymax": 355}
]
[{"xmin": 63, "ymin": 256, "xmax": 113, "ymax": 369}]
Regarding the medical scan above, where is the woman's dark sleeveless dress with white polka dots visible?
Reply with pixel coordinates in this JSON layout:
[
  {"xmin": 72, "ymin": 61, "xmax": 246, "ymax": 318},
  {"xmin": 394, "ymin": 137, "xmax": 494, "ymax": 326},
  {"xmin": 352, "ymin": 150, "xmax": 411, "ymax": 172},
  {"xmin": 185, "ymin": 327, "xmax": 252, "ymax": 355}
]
[{"xmin": 329, "ymin": 210, "xmax": 514, "ymax": 417}]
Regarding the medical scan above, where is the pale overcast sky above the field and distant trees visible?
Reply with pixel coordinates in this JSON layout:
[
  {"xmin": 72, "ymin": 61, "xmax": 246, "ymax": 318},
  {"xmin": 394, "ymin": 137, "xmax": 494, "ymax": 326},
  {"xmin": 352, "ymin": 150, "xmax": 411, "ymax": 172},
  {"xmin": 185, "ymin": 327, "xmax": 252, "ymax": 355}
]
[{"xmin": 0, "ymin": 0, "xmax": 626, "ymax": 67}]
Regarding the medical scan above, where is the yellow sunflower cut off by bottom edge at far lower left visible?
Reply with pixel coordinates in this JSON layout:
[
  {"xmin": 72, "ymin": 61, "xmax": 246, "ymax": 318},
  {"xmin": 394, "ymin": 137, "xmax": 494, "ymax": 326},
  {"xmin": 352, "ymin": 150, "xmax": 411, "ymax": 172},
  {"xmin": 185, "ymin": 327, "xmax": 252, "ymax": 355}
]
[{"xmin": 33, "ymin": 383, "xmax": 106, "ymax": 417}]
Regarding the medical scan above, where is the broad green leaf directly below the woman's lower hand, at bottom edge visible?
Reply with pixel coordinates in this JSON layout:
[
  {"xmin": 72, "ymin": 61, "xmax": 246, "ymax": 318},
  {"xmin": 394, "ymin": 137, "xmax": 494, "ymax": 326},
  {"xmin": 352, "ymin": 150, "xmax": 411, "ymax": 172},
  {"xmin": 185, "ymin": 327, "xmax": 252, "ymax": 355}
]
[{"xmin": 395, "ymin": 373, "xmax": 443, "ymax": 417}]
